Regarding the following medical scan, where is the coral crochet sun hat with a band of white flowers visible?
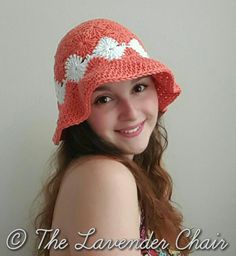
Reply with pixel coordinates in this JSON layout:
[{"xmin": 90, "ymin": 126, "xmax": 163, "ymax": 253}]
[{"xmin": 53, "ymin": 19, "xmax": 181, "ymax": 145}]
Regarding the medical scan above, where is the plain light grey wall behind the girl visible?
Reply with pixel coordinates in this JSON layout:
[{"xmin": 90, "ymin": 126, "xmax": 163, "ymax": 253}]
[{"xmin": 0, "ymin": 0, "xmax": 236, "ymax": 256}]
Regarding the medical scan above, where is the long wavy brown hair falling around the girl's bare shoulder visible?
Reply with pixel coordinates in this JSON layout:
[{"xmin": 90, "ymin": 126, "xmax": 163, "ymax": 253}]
[{"xmin": 34, "ymin": 114, "xmax": 190, "ymax": 256}]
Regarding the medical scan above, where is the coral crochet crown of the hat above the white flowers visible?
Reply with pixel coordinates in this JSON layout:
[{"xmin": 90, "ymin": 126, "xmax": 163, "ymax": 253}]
[{"xmin": 54, "ymin": 19, "xmax": 143, "ymax": 81}]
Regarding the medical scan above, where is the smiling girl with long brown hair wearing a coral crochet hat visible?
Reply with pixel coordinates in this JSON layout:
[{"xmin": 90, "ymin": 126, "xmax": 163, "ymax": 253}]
[{"xmin": 35, "ymin": 19, "xmax": 189, "ymax": 256}]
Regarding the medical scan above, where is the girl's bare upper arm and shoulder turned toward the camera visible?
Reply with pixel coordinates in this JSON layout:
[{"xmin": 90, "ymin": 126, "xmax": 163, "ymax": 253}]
[{"xmin": 56, "ymin": 159, "xmax": 141, "ymax": 256}]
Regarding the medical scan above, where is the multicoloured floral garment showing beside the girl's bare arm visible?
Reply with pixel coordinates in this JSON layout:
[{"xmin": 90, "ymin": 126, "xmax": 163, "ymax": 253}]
[{"xmin": 140, "ymin": 210, "xmax": 181, "ymax": 256}]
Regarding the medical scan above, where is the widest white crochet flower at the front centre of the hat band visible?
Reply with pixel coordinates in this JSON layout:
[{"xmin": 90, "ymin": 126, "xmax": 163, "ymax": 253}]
[{"xmin": 93, "ymin": 37, "xmax": 126, "ymax": 60}]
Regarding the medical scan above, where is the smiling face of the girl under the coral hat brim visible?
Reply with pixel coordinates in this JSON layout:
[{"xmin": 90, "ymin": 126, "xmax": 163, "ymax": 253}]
[{"xmin": 87, "ymin": 76, "xmax": 158, "ymax": 159}]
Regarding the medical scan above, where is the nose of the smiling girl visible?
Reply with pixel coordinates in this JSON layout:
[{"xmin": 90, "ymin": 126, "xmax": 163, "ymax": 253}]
[{"xmin": 119, "ymin": 99, "xmax": 138, "ymax": 121}]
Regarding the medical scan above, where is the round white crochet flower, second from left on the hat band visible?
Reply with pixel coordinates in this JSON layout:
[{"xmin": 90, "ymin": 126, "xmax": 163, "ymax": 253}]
[{"xmin": 65, "ymin": 54, "xmax": 87, "ymax": 82}]
